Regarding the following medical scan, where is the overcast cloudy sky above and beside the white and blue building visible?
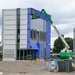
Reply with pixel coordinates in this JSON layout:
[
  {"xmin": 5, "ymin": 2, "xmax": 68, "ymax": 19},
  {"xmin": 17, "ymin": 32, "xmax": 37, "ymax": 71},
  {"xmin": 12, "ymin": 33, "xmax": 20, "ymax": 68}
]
[{"xmin": 0, "ymin": 0, "xmax": 75, "ymax": 44}]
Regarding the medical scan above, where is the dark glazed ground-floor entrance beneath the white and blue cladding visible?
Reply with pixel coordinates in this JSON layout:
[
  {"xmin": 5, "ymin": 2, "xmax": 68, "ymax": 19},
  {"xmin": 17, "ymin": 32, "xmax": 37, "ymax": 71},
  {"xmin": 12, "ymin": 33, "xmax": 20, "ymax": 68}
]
[{"xmin": 16, "ymin": 50, "xmax": 36, "ymax": 60}]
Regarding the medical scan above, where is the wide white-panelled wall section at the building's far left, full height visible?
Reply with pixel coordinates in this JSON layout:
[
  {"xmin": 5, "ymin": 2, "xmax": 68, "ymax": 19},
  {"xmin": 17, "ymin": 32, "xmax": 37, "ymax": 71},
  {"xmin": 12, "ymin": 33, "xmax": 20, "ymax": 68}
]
[{"xmin": 2, "ymin": 9, "xmax": 17, "ymax": 61}]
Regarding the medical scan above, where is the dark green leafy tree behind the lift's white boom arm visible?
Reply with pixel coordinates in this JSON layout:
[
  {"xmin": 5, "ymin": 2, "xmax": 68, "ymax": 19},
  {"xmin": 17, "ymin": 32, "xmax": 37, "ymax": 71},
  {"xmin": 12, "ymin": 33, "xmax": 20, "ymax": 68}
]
[{"xmin": 53, "ymin": 37, "xmax": 73, "ymax": 53}]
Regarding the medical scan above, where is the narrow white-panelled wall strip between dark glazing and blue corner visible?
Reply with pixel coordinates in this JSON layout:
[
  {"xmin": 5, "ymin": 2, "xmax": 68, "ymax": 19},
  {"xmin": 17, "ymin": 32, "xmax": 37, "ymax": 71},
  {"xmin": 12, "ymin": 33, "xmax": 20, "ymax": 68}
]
[{"xmin": 20, "ymin": 9, "xmax": 27, "ymax": 49}]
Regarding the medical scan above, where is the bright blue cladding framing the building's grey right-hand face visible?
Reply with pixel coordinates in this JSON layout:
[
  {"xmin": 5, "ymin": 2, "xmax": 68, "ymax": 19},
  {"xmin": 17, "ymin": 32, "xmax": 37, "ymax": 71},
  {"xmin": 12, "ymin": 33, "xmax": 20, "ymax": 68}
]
[{"xmin": 27, "ymin": 8, "xmax": 51, "ymax": 59}]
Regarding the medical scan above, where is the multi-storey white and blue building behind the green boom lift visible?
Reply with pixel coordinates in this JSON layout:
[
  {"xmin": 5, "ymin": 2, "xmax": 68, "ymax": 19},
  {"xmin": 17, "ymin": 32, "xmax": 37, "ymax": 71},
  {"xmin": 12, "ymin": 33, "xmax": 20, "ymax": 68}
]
[{"xmin": 2, "ymin": 8, "xmax": 51, "ymax": 61}]
